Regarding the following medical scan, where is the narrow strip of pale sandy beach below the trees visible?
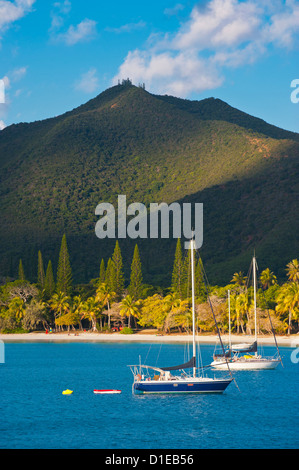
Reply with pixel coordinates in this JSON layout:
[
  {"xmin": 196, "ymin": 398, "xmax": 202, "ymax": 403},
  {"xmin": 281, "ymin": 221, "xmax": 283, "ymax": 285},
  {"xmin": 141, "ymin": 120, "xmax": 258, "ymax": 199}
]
[{"xmin": 0, "ymin": 331, "xmax": 299, "ymax": 347}]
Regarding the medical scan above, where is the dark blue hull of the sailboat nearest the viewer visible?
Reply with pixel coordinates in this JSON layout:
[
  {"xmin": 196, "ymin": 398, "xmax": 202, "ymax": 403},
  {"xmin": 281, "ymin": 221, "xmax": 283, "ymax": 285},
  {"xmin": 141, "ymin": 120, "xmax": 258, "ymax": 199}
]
[{"xmin": 133, "ymin": 379, "xmax": 232, "ymax": 394}]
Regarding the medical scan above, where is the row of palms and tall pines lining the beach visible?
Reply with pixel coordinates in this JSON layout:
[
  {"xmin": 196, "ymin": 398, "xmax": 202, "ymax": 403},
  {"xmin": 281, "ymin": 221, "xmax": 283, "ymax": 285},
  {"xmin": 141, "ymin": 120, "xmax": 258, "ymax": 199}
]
[{"xmin": 0, "ymin": 239, "xmax": 299, "ymax": 334}]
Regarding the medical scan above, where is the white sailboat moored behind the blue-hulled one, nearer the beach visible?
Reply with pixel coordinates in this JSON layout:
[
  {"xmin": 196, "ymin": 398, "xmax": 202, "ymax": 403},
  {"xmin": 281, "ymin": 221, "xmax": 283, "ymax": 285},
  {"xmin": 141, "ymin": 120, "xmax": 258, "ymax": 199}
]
[{"xmin": 211, "ymin": 255, "xmax": 281, "ymax": 370}]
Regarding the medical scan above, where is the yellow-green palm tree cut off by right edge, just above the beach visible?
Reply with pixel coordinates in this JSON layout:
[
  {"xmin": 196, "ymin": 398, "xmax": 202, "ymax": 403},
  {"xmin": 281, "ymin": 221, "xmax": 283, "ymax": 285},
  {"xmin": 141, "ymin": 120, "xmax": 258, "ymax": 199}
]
[{"xmin": 276, "ymin": 282, "xmax": 299, "ymax": 335}]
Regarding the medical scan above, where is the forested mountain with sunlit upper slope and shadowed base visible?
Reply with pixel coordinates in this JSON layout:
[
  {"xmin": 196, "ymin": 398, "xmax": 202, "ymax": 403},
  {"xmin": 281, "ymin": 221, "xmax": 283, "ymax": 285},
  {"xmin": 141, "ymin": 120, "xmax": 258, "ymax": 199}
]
[{"xmin": 0, "ymin": 81, "xmax": 299, "ymax": 285}]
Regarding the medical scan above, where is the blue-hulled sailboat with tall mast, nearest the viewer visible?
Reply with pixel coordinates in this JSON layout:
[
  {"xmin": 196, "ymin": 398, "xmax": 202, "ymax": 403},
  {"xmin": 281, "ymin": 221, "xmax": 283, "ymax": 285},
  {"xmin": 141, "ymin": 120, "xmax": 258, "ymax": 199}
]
[{"xmin": 129, "ymin": 240, "xmax": 233, "ymax": 394}]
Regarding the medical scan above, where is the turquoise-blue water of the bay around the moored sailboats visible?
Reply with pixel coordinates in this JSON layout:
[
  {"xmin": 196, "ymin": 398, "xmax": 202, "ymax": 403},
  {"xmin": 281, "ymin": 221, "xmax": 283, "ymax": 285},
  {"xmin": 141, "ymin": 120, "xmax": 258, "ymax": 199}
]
[{"xmin": 0, "ymin": 343, "xmax": 299, "ymax": 449}]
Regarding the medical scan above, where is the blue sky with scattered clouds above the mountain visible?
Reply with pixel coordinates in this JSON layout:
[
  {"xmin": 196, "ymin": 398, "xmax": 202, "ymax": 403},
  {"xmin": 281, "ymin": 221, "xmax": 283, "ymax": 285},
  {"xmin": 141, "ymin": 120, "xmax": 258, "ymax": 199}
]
[{"xmin": 0, "ymin": 0, "xmax": 299, "ymax": 132}]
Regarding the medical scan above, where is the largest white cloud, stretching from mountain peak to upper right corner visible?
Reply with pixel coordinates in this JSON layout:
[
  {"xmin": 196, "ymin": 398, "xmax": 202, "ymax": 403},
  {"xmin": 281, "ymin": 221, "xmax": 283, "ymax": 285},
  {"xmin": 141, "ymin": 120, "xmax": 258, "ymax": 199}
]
[{"xmin": 113, "ymin": 0, "xmax": 299, "ymax": 97}]
